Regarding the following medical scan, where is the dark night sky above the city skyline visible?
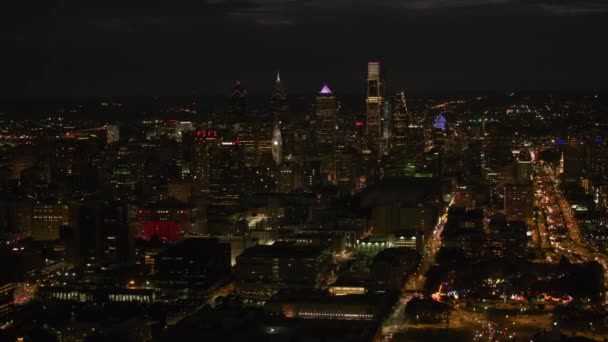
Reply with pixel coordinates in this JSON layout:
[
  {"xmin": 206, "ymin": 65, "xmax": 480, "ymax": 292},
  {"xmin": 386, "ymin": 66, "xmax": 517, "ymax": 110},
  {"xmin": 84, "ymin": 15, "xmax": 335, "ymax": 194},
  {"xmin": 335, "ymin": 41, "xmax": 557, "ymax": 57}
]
[{"xmin": 0, "ymin": 0, "xmax": 608, "ymax": 96}]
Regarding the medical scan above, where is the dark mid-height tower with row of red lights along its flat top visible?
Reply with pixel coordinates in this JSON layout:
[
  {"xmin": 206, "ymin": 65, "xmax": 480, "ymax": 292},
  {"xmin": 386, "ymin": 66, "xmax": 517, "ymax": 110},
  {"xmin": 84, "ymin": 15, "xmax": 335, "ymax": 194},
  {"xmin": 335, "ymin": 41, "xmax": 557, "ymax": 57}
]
[{"xmin": 192, "ymin": 129, "xmax": 220, "ymax": 195}]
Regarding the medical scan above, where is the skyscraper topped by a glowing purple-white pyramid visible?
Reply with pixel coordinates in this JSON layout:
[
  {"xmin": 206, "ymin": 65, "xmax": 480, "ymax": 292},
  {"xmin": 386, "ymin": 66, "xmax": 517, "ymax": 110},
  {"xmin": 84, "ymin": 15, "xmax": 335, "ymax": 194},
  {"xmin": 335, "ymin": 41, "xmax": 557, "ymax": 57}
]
[{"xmin": 315, "ymin": 85, "xmax": 338, "ymax": 182}]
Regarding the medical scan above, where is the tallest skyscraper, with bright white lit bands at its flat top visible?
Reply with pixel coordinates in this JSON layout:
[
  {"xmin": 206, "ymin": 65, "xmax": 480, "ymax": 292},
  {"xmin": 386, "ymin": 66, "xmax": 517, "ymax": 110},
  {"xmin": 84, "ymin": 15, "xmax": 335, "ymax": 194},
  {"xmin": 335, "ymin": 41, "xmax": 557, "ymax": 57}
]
[{"xmin": 365, "ymin": 62, "xmax": 384, "ymax": 150}]
